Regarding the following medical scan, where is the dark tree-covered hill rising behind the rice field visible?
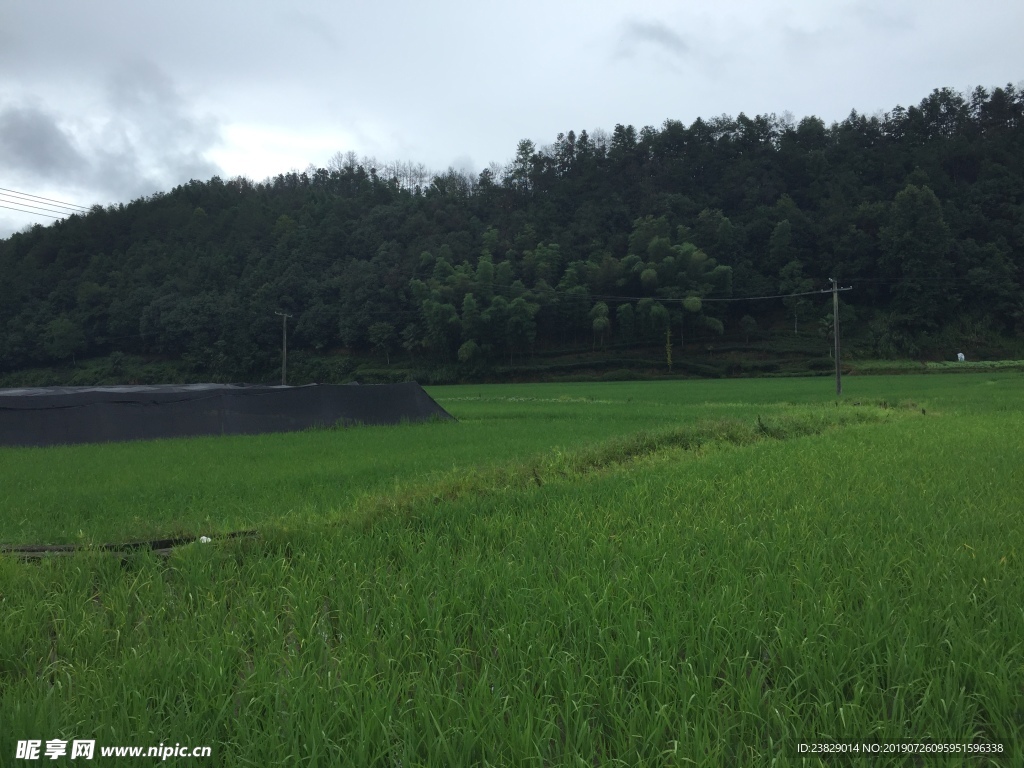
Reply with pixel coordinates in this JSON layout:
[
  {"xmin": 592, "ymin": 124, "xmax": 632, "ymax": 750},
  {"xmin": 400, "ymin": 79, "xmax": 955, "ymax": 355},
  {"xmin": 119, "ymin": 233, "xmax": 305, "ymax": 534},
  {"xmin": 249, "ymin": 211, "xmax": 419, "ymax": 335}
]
[{"xmin": 0, "ymin": 86, "xmax": 1024, "ymax": 379}]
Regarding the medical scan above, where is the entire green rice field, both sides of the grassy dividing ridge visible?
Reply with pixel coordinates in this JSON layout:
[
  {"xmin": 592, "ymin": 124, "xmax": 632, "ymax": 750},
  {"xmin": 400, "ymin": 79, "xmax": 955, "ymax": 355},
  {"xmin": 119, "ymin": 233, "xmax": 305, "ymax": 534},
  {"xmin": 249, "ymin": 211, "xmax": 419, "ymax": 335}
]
[{"xmin": 0, "ymin": 370, "xmax": 1024, "ymax": 768}]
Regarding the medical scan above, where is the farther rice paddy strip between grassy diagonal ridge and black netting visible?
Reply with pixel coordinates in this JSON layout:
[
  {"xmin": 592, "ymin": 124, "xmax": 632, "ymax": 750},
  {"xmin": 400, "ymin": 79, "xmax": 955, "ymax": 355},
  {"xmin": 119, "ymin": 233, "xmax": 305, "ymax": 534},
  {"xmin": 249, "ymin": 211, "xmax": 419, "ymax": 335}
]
[{"xmin": 0, "ymin": 374, "xmax": 921, "ymax": 544}]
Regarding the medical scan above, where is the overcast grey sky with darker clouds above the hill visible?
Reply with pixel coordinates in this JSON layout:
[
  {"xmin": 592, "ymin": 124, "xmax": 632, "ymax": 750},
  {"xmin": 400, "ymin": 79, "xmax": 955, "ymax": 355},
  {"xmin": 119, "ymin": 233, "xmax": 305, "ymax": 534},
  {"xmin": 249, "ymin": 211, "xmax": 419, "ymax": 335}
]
[{"xmin": 0, "ymin": 0, "xmax": 1024, "ymax": 237}]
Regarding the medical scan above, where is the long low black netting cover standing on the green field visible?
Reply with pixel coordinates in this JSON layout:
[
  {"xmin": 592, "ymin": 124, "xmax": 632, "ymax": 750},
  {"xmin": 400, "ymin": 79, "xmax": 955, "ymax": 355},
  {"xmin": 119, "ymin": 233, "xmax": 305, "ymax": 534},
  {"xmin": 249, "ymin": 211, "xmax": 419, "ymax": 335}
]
[{"xmin": 0, "ymin": 382, "xmax": 452, "ymax": 445}]
